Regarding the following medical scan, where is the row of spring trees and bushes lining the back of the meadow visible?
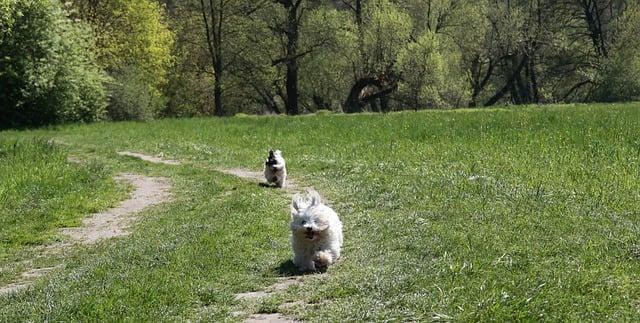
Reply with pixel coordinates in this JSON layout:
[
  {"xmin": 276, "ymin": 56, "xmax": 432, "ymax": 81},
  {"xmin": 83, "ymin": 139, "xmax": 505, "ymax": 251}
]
[{"xmin": 0, "ymin": 0, "xmax": 640, "ymax": 129}]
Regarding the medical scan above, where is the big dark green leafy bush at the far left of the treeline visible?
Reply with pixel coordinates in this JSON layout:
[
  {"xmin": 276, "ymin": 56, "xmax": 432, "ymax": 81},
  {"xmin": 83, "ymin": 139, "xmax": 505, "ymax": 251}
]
[{"xmin": 0, "ymin": 0, "xmax": 107, "ymax": 128}]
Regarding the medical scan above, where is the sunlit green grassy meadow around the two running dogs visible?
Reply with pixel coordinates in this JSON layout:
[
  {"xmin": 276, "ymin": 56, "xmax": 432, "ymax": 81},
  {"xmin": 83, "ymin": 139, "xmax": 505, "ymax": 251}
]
[{"xmin": 0, "ymin": 104, "xmax": 640, "ymax": 321}]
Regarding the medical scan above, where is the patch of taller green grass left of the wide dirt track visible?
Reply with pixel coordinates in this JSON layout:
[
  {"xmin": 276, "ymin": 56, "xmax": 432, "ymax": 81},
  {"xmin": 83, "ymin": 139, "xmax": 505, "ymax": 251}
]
[{"xmin": 0, "ymin": 139, "xmax": 125, "ymax": 282}]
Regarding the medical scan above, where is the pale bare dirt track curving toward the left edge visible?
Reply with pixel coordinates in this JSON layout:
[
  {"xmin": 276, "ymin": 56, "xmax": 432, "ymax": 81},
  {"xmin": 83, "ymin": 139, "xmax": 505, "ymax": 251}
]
[{"xmin": 0, "ymin": 174, "xmax": 171, "ymax": 295}]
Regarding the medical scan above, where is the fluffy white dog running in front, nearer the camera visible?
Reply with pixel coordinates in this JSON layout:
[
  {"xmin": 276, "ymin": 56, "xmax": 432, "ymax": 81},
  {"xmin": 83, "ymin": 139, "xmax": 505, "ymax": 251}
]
[{"xmin": 290, "ymin": 190, "xmax": 342, "ymax": 272}]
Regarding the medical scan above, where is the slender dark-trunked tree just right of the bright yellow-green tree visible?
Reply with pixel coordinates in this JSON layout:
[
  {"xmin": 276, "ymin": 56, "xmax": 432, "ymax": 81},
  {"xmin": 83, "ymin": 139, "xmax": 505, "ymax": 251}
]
[{"xmin": 165, "ymin": 0, "xmax": 271, "ymax": 116}]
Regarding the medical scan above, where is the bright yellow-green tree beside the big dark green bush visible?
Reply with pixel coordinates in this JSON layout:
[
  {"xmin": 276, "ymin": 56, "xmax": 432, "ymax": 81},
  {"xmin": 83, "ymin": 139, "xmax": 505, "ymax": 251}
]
[{"xmin": 74, "ymin": 0, "xmax": 174, "ymax": 120}]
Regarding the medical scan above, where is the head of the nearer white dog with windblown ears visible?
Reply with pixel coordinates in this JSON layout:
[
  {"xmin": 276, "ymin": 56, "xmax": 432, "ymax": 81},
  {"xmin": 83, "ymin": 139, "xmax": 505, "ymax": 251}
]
[{"xmin": 290, "ymin": 191, "xmax": 329, "ymax": 241}]
